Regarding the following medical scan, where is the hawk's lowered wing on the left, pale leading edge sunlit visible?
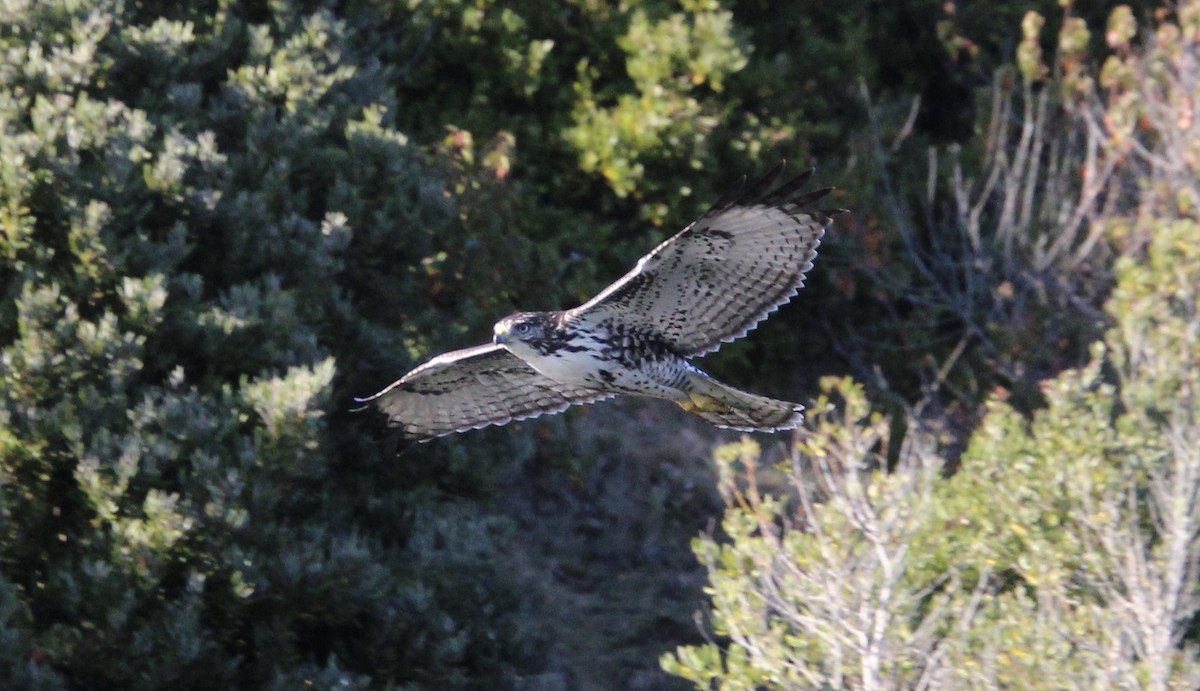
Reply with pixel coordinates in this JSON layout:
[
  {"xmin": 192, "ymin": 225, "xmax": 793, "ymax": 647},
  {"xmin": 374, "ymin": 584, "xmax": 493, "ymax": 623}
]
[{"xmin": 358, "ymin": 343, "xmax": 612, "ymax": 441}]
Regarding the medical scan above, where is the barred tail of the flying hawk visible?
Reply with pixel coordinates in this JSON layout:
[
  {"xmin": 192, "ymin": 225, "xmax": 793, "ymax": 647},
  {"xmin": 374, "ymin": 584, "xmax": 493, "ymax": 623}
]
[{"xmin": 677, "ymin": 369, "xmax": 804, "ymax": 432}]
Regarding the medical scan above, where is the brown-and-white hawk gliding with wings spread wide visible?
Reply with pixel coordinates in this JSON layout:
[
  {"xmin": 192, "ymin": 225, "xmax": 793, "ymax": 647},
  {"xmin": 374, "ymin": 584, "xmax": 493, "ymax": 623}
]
[{"xmin": 359, "ymin": 163, "xmax": 844, "ymax": 441}]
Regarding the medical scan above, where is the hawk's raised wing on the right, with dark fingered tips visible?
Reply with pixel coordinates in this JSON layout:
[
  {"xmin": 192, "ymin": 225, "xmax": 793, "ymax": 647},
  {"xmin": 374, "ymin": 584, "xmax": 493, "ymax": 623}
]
[{"xmin": 568, "ymin": 163, "xmax": 842, "ymax": 357}]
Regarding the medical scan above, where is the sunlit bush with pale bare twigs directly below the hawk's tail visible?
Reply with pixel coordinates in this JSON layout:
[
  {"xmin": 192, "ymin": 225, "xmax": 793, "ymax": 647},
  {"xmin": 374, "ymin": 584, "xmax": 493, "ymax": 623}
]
[{"xmin": 662, "ymin": 379, "xmax": 962, "ymax": 691}]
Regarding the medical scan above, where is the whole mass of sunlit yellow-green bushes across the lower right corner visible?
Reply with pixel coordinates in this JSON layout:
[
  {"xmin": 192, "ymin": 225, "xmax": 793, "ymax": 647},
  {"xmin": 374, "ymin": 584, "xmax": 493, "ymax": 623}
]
[{"xmin": 662, "ymin": 222, "xmax": 1200, "ymax": 689}]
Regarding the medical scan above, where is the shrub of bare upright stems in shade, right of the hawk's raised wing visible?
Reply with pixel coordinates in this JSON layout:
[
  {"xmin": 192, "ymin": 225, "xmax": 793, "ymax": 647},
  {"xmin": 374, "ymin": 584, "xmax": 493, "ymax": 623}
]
[{"xmin": 829, "ymin": 2, "xmax": 1171, "ymax": 431}]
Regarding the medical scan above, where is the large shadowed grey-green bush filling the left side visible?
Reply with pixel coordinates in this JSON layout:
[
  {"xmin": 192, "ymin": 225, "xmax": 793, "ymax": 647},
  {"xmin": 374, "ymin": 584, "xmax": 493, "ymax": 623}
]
[{"xmin": 0, "ymin": 1, "xmax": 535, "ymax": 689}]
